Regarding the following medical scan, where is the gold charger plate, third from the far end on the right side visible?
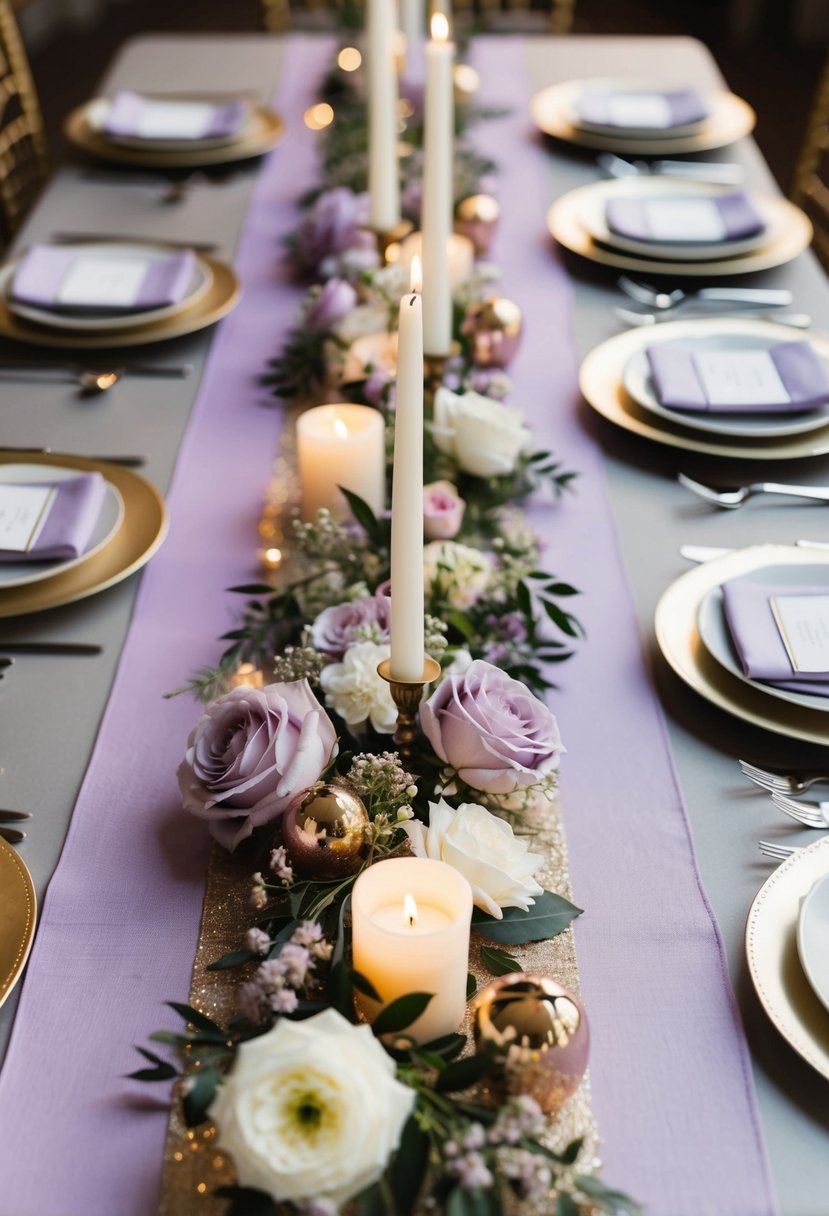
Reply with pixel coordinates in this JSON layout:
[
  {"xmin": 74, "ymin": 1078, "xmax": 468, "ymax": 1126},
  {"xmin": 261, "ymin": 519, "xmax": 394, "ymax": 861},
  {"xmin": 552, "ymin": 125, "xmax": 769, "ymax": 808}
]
[{"xmin": 579, "ymin": 317, "xmax": 829, "ymax": 460}]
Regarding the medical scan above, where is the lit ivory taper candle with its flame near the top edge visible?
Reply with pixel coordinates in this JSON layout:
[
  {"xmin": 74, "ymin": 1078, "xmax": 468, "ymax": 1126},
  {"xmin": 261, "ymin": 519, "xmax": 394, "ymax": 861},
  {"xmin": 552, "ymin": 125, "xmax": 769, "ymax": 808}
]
[{"xmin": 421, "ymin": 13, "xmax": 455, "ymax": 355}]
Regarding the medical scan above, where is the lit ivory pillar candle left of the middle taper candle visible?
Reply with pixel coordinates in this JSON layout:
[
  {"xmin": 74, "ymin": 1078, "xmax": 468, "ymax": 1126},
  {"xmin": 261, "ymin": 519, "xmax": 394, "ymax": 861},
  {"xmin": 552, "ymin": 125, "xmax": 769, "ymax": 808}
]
[{"xmin": 297, "ymin": 402, "xmax": 385, "ymax": 520}]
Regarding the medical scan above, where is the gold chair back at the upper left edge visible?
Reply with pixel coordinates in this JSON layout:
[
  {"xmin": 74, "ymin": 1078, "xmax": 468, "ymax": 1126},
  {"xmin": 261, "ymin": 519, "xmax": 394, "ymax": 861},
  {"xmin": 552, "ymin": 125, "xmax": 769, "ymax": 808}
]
[{"xmin": 0, "ymin": 0, "xmax": 49, "ymax": 244}]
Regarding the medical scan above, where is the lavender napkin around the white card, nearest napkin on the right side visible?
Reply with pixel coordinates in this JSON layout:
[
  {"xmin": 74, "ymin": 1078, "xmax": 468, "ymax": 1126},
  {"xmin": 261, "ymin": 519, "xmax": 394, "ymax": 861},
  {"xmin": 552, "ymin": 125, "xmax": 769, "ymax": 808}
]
[{"xmin": 722, "ymin": 579, "xmax": 829, "ymax": 697}]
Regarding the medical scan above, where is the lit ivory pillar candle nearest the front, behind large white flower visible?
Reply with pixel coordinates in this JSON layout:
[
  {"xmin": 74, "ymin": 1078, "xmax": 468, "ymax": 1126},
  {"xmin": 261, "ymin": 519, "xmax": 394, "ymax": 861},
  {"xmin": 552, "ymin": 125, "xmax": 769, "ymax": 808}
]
[{"xmin": 351, "ymin": 857, "xmax": 472, "ymax": 1043}]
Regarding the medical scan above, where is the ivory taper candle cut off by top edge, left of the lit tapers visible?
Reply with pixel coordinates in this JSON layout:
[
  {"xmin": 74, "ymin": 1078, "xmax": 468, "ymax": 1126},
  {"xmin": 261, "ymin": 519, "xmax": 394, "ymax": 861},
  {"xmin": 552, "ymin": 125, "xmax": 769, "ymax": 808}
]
[{"xmin": 366, "ymin": 0, "xmax": 400, "ymax": 232}]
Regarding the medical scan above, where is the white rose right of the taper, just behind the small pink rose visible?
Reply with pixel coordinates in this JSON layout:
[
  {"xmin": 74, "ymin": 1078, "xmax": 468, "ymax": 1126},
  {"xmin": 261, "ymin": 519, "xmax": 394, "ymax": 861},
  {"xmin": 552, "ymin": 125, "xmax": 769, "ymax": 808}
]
[{"xmin": 432, "ymin": 388, "xmax": 531, "ymax": 477}]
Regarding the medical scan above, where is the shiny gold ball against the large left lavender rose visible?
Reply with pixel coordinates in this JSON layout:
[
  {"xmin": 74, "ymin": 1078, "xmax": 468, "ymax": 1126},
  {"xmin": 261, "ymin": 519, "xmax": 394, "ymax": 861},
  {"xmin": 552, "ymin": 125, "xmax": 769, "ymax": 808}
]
[{"xmin": 282, "ymin": 781, "xmax": 371, "ymax": 878}]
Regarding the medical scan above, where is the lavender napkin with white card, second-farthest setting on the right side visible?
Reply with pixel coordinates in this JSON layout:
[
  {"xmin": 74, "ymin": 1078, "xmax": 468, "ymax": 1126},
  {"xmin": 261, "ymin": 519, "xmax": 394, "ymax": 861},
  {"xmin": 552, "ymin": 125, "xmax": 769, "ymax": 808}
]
[{"xmin": 604, "ymin": 190, "xmax": 766, "ymax": 244}]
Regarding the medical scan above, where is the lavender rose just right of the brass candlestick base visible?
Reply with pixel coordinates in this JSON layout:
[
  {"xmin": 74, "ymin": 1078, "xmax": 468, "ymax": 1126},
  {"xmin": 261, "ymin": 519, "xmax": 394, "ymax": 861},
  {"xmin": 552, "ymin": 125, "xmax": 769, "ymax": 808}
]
[{"xmin": 421, "ymin": 659, "xmax": 564, "ymax": 794}]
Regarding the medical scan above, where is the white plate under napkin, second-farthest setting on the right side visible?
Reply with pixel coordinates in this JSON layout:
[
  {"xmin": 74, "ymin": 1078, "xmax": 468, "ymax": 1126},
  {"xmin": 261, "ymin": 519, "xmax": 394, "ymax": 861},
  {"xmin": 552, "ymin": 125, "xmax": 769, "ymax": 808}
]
[{"xmin": 580, "ymin": 178, "xmax": 785, "ymax": 261}]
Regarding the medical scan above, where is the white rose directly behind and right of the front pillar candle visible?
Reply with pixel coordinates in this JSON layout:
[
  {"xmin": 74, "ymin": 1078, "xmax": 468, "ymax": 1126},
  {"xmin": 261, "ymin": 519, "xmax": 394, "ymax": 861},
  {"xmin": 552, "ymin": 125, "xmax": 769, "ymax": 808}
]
[{"xmin": 404, "ymin": 798, "xmax": 545, "ymax": 921}]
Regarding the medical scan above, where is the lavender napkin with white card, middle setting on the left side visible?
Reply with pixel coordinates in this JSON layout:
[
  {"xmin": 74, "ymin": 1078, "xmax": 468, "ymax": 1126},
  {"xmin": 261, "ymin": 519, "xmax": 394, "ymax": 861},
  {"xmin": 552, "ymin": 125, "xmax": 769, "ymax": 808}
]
[{"xmin": 10, "ymin": 244, "xmax": 196, "ymax": 316}]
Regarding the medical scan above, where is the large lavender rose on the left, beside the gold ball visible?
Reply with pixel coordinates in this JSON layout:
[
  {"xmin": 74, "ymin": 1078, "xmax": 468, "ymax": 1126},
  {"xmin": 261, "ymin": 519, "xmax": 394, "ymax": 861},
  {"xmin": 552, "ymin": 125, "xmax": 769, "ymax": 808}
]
[{"xmin": 177, "ymin": 680, "xmax": 337, "ymax": 849}]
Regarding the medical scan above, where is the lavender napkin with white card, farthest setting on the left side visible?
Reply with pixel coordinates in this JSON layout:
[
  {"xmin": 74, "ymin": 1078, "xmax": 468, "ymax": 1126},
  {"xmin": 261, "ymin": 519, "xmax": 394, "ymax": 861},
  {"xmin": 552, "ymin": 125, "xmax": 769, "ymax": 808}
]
[{"xmin": 103, "ymin": 89, "xmax": 249, "ymax": 142}]
